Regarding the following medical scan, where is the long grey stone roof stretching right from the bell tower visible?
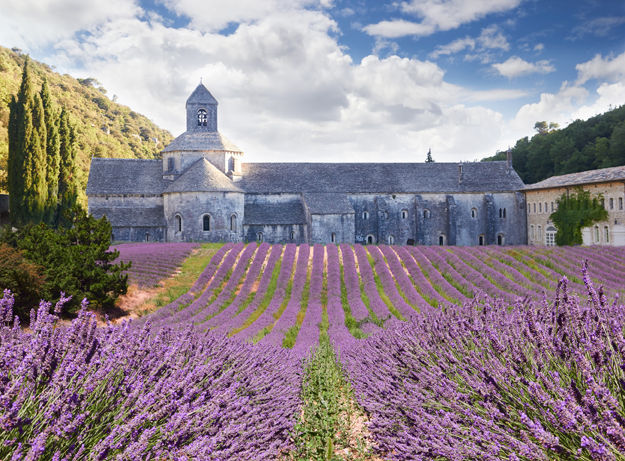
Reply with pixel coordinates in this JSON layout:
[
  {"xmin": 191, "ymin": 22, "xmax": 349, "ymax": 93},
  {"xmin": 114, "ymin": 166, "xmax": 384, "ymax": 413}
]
[{"xmin": 237, "ymin": 161, "xmax": 524, "ymax": 194}]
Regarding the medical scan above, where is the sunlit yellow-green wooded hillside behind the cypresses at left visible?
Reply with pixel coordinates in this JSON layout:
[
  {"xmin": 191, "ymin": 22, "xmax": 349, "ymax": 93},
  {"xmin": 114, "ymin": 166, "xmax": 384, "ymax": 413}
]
[{"xmin": 0, "ymin": 47, "xmax": 173, "ymax": 193}]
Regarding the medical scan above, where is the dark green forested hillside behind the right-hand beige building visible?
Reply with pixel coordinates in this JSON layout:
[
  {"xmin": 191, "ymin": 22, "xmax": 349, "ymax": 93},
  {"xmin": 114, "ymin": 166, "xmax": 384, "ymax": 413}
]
[{"xmin": 482, "ymin": 106, "xmax": 625, "ymax": 184}]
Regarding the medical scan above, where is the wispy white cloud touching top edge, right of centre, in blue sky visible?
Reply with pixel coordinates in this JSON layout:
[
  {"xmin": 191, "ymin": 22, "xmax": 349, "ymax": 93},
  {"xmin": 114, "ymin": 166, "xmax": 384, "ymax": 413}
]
[{"xmin": 364, "ymin": 0, "xmax": 521, "ymax": 38}]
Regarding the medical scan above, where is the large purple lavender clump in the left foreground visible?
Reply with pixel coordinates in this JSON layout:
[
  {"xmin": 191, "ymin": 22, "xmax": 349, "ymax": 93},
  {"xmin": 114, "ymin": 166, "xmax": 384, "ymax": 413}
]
[{"xmin": 0, "ymin": 292, "xmax": 302, "ymax": 461}]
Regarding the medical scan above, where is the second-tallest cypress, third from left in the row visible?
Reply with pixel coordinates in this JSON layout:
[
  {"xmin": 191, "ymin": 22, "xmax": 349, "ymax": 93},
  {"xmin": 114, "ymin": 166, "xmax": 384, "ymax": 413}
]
[{"xmin": 41, "ymin": 80, "xmax": 61, "ymax": 225}]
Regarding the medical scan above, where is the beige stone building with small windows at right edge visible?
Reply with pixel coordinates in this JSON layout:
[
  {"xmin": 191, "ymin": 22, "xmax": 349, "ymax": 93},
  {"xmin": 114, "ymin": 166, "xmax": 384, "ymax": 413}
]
[{"xmin": 524, "ymin": 166, "xmax": 625, "ymax": 246}]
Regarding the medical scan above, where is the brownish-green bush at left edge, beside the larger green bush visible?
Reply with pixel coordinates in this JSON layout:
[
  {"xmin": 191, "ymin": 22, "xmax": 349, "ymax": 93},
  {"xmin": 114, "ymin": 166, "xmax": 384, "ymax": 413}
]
[{"xmin": 0, "ymin": 243, "xmax": 45, "ymax": 319}]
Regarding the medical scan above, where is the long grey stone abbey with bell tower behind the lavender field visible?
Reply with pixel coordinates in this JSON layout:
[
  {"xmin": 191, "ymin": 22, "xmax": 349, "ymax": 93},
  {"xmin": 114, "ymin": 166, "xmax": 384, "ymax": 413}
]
[{"xmin": 87, "ymin": 84, "xmax": 527, "ymax": 245}]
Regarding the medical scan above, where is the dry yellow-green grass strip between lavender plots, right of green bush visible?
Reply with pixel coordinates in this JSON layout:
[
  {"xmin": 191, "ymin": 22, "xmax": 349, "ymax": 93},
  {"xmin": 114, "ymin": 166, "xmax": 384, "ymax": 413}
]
[{"xmin": 134, "ymin": 243, "xmax": 223, "ymax": 315}]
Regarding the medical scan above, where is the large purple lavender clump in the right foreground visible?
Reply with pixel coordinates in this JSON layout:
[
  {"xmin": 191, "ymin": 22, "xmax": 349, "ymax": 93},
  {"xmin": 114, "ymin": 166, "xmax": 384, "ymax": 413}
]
[{"xmin": 340, "ymin": 264, "xmax": 625, "ymax": 460}]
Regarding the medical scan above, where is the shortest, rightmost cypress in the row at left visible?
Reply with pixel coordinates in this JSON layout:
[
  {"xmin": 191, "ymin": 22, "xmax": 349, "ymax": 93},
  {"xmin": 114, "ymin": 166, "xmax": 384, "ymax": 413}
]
[{"xmin": 57, "ymin": 108, "xmax": 78, "ymax": 226}]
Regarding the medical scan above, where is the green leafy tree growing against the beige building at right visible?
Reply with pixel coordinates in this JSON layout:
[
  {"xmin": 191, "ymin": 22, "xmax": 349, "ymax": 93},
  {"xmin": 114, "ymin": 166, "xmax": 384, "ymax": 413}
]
[{"xmin": 549, "ymin": 188, "xmax": 608, "ymax": 245}]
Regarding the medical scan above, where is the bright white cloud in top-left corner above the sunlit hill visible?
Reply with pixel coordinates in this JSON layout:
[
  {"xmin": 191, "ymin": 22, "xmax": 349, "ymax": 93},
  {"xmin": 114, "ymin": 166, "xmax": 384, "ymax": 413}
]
[{"xmin": 0, "ymin": 0, "xmax": 142, "ymax": 49}]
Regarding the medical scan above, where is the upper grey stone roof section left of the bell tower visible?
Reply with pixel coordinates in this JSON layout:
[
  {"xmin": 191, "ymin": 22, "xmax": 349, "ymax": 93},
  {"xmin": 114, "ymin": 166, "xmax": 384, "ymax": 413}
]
[{"xmin": 87, "ymin": 158, "xmax": 165, "ymax": 195}]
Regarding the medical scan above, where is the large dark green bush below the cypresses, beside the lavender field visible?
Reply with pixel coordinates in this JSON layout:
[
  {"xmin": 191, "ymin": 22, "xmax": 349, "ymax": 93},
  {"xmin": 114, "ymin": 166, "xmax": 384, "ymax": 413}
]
[{"xmin": 0, "ymin": 208, "xmax": 130, "ymax": 313}]
